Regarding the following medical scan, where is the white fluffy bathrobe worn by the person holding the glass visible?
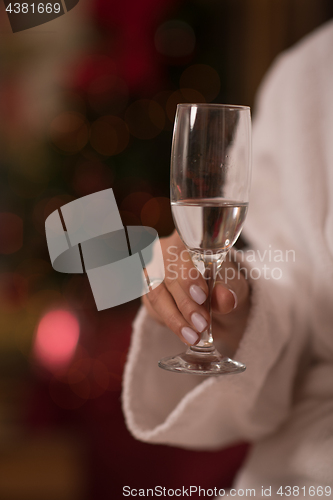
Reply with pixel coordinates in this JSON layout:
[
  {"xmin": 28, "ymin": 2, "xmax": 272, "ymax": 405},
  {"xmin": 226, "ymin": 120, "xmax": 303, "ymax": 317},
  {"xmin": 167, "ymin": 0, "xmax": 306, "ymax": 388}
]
[{"xmin": 123, "ymin": 22, "xmax": 333, "ymax": 499}]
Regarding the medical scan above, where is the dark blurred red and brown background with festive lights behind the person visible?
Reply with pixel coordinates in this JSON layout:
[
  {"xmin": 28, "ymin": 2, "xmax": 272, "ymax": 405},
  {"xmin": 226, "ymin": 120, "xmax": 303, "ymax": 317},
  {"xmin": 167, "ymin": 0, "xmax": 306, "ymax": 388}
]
[{"xmin": 0, "ymin": 0, "xmax": 333, "ymax": 500}]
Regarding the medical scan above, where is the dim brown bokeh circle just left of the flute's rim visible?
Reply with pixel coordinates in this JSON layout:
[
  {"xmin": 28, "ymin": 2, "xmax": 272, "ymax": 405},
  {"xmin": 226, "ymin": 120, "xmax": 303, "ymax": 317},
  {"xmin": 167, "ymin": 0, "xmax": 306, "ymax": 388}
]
[{"xmin": 125, "ymin": 99, "xmax": 165, "ymax": 139}]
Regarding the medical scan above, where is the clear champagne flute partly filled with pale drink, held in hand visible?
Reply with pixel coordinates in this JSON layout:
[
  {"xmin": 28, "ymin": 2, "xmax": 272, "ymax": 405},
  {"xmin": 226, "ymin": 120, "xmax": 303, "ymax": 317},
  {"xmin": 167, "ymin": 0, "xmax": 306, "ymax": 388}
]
[{"xmin": 159, "ymin": 104, "xmax": 251, "ymax": 375}]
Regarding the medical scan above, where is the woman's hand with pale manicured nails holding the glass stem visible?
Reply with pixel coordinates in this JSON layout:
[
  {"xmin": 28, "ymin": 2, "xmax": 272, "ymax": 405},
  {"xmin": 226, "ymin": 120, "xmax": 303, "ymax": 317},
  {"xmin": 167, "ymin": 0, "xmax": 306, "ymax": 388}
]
[{"xmin": 143, "ymin": 231, "xmax": 250, "ymax": 355}]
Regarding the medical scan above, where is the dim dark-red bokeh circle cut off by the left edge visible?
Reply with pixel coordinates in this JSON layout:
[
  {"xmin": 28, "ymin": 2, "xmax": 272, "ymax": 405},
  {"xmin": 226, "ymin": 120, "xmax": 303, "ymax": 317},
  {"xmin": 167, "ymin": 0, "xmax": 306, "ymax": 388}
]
[{"xmin": 0, "ymin": 212, "xmax": 23, "ymax": 255}]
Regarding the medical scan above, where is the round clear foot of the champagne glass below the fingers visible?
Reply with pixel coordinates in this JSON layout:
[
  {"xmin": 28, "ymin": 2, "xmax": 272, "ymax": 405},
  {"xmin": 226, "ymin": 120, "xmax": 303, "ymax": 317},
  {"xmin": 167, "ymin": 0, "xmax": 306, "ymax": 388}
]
[{"xmin": 158, "ymin": 346, "xmax": 246, "ymax": 375}]
